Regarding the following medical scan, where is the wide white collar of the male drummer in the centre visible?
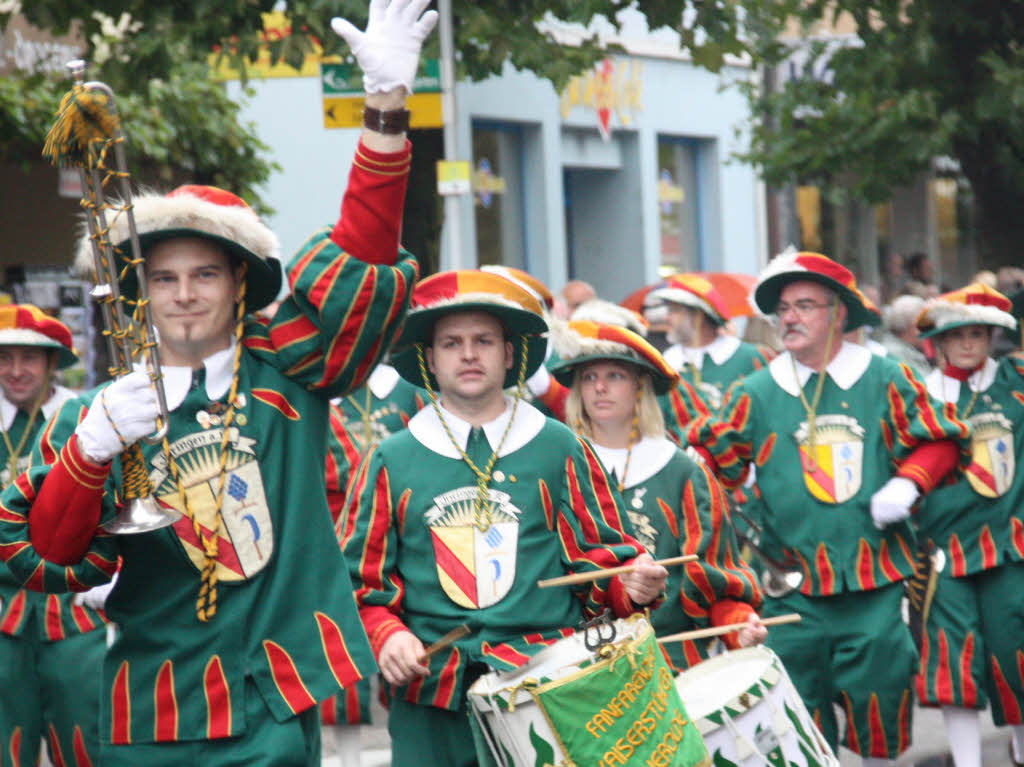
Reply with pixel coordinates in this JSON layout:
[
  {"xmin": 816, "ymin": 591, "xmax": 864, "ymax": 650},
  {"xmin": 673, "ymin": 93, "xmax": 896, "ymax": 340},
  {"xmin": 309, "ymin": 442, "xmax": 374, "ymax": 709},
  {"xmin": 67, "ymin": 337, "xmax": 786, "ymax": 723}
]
[{"xmin": 409, "ymin": 396, "xmax": 548, "ymax": 459}]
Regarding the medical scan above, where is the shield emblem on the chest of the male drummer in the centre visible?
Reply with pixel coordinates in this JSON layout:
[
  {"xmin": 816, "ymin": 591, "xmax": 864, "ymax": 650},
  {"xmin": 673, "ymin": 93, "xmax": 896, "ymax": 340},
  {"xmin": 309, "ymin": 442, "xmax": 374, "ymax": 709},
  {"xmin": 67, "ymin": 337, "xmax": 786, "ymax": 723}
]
[{"xmin": 426, "ymin": 485, "xmax": 521, "ymax": 609}]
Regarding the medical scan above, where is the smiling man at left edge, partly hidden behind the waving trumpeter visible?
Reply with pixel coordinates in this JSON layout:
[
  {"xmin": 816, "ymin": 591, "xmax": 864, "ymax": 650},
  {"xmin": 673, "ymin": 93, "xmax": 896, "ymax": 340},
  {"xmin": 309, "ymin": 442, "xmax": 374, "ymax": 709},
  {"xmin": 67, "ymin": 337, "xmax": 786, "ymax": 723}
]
[{"xmin": 0, "ymin": 304, "xmax": 109, "ymax": 765}]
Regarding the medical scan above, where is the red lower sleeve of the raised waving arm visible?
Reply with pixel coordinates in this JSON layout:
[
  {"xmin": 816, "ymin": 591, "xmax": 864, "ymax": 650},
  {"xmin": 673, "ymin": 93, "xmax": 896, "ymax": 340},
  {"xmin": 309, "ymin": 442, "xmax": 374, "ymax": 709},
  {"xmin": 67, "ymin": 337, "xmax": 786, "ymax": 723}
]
[{"xmin": 331, "ymin": 140, "xmax": 412, "ymax": 265}]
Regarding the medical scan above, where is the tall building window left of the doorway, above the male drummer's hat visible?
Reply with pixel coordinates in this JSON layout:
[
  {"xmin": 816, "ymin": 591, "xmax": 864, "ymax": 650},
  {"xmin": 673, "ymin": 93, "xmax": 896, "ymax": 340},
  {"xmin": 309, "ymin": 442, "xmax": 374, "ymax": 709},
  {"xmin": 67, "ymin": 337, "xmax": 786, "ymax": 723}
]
[{"xmin": 472, "ymin": 122, "xmax": 527, "ymax": 269}]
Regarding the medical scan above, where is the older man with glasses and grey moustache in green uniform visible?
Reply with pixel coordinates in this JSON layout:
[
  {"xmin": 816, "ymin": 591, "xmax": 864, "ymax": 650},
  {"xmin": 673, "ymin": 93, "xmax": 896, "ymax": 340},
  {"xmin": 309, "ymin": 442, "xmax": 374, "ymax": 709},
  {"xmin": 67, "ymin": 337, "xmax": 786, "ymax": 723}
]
[{"xmin": 687, "ymin": 253, "xmax": 969, "ymax": 765}]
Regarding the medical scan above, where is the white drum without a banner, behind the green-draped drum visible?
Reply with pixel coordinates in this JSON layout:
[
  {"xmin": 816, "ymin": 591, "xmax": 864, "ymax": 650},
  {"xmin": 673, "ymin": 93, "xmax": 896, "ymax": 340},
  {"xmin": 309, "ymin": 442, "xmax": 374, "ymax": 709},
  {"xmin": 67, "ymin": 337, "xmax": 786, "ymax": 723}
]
[{"xmin": 676, "ymin": 647, "xmax": 839, "ymax": 767}]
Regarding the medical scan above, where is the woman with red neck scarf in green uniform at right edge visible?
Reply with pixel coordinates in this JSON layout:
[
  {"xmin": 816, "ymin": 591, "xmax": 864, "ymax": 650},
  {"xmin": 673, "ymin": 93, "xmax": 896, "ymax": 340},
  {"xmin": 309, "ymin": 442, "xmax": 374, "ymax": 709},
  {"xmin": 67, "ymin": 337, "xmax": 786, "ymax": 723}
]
[{"xmin": 901, "ymin": 283, "xmax": 1024, "ymax": 767}]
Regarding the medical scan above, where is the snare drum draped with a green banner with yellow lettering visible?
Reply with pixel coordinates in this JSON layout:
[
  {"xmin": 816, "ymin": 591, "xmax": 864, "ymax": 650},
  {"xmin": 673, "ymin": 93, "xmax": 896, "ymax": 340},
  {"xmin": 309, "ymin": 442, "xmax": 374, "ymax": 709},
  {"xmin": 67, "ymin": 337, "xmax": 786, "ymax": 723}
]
[{"xmin": 468, "ymin": 615, "xmax": 711, "ymax": 767}]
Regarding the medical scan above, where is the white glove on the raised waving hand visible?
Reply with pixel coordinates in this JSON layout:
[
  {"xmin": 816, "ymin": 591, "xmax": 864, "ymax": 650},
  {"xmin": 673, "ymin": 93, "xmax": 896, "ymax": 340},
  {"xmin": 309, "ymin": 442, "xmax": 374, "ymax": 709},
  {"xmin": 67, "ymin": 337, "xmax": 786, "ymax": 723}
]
[{"xmin": 331, "ymin": 0, "xmax": 437, "ymax": 93}]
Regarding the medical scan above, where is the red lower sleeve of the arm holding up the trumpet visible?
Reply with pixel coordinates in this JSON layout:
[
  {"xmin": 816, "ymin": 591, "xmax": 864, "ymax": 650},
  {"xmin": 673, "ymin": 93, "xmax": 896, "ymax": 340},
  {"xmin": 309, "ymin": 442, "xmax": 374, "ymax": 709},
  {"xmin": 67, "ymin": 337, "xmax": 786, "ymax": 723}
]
[{"xmin": 29, "ymin": 434, "xmax": 111, "ymax": 564}]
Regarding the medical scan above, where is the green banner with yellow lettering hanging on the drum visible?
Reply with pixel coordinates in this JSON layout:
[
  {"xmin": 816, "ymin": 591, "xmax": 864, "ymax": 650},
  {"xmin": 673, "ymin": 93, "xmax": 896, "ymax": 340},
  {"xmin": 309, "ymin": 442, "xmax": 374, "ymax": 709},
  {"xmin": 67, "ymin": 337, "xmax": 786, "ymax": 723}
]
[{"xmin": 530, "ymin": 632, "xmax": 711, "ymax": 767}]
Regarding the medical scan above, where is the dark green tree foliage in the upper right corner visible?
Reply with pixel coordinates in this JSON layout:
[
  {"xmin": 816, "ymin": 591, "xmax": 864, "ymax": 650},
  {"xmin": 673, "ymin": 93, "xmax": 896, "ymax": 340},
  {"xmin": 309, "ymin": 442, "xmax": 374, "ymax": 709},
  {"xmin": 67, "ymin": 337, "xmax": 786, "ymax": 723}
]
[{"xmin": 744, "ymin": 0, "xmax": 1024, "ymax": 263}]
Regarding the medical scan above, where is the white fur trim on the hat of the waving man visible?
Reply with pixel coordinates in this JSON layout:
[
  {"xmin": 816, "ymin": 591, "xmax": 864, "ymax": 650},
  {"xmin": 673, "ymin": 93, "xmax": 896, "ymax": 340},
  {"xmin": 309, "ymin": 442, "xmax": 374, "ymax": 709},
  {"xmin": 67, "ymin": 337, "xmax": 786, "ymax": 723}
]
[{"xmin": 75, "ymin": 191, "xmax": 281, "ymax": 276}]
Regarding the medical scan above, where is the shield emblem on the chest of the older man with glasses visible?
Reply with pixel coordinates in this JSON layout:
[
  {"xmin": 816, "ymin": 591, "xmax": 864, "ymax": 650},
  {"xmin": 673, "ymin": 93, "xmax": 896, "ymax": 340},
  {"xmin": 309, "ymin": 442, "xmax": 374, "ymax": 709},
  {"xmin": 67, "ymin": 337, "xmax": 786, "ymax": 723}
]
[{"xmin": 794, "ymin": 415, "xmax": 864, "ymax": 504}]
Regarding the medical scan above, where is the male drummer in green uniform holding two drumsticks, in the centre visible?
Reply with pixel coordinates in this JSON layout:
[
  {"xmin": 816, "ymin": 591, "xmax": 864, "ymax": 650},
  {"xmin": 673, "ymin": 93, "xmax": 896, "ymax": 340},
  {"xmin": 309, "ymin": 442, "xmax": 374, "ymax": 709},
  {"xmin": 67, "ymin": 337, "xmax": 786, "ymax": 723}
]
[{"xmin": 342, "ymin": 270, "xmax": 668, "ymax": 767}]
